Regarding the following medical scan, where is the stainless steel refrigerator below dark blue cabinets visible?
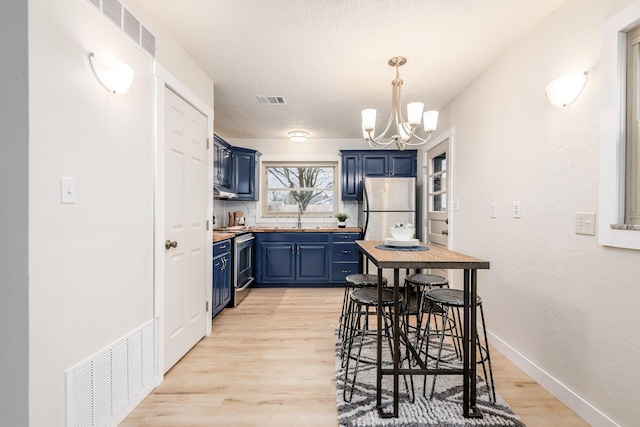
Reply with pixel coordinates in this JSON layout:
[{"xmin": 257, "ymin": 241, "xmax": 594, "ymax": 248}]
[{"xmin": 359, "ymin": 178, "xmax": 417, "ymax": 284}]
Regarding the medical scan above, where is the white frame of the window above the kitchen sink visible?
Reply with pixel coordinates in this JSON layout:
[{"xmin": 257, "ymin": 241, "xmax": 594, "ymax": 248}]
[{"xmin": 260, "ymin": 160, "xmax": 340, "ymax": 220}]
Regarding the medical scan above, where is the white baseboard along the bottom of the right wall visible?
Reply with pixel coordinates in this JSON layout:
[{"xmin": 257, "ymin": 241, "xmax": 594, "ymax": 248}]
[{"xmin": 487, "ymin": 331, "xmax": 620, "ymax": 427}]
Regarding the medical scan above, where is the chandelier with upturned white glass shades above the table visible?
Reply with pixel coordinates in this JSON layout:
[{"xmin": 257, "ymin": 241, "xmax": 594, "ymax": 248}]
[{"xmin": 362, "ymin": 56, "xmax": 438, "ymax": 150}]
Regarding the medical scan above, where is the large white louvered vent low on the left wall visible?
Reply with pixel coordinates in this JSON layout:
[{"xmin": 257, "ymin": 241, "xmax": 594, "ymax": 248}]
[{"xmin": 66, "ymin": 321, "xmax": 157, "ymax": 427}]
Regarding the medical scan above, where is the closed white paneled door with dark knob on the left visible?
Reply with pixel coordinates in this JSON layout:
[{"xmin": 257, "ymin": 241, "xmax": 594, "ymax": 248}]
[{"xmin": 163, "ymin": 88, "xmax": 208, "ymax": 372}]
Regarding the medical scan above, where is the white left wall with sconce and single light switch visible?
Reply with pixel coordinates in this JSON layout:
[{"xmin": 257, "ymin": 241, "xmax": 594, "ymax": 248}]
[{"xmin": 23, "ymin": 0, "xmax": 213, "ymax": 425}]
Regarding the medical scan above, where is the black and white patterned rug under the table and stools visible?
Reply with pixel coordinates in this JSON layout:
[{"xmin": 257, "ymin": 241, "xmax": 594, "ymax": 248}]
[{"xmin": 335, "ymin": 334, "xmax": 524, "ymax": 427}]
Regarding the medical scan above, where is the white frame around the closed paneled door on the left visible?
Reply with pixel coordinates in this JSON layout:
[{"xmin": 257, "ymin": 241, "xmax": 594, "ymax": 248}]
[{"xmin": 153, "ymin": 62, "xmax": 213, "ymax": 386}]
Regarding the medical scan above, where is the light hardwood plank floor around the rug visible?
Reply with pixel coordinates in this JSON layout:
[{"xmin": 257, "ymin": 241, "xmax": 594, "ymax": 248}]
[{"xmin": 121, "ymin": 288, "xmax": 588, "ymax": 427}]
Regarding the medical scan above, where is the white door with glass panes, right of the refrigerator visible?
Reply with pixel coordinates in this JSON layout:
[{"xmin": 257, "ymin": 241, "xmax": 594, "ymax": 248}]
[{"xmin": 423, "ymin": 138, "xmax": 450, "ymax": 277}]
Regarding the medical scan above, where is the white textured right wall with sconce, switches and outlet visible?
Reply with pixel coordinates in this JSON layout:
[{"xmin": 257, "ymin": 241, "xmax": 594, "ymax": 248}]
[{"xmin": 439, "ymin": 0, "xmax": 640, "ymax": 426}]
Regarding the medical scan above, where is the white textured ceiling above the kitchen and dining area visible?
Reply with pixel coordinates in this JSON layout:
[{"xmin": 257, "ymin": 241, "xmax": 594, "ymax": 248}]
[{"xmin": 139, "ymin": 0, "xmax": 566, "ymax": 138}]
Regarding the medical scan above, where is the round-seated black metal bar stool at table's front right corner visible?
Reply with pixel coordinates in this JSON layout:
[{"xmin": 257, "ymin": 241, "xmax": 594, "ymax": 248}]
[{"xmin": 424, "ymin": 288, "xmax": 496, "ymax": 403}]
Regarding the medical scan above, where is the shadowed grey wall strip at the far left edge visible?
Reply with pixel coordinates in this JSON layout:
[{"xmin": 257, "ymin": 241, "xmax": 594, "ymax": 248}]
[{"xmin": 0, "ymin": 0, "xmax": 29, "ymax": 426}]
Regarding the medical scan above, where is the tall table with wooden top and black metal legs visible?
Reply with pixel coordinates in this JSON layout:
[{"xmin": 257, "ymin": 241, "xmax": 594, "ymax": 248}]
[{"xmin": 356, "ymin": 240, "xmax": 489, "ymax": 418}]
